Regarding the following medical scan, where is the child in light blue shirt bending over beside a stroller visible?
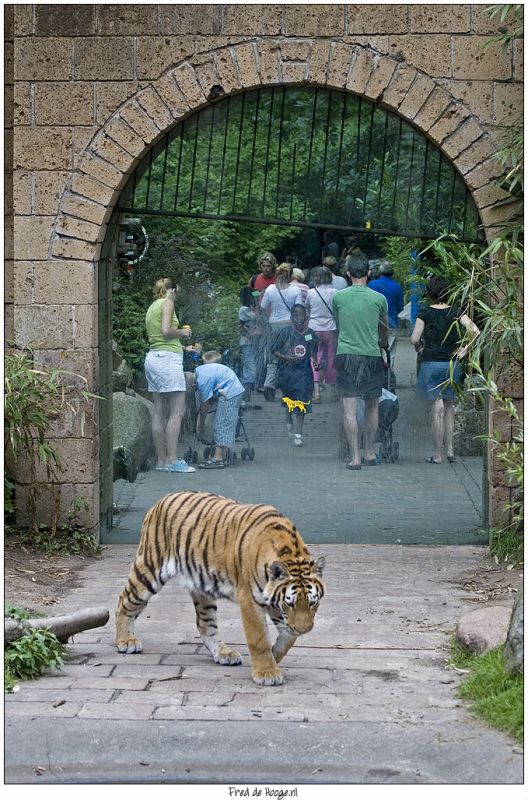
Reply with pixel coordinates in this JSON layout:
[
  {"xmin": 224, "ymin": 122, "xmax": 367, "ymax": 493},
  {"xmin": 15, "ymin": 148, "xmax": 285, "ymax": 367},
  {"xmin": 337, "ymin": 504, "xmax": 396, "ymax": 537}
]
[{"xmin": 194, "ymin": 350, "xmax": 245, "ymax": 469}]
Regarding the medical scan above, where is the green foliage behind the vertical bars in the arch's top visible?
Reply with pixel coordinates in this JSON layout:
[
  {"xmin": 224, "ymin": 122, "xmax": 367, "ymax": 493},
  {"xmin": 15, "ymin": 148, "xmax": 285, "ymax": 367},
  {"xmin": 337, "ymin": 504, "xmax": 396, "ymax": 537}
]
[{"xmin": 127, "ymin": 87, "xmax": 477, "ymax": 241}]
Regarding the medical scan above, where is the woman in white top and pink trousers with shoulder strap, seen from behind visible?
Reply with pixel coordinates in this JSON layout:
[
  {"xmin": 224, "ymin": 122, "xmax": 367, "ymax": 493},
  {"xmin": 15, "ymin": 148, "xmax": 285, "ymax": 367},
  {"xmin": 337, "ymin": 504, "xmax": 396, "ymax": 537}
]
[{"xmin": 306, "ymin": 267, "xmax": 338, "ymax": 403}]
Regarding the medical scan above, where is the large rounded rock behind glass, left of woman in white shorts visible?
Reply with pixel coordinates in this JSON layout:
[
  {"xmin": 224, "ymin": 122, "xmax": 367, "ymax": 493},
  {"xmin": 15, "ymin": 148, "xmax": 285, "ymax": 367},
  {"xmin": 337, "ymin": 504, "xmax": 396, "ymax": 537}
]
[{"xmin": 113, "ymin": 392, "xmax": 155, "ymax": 482}]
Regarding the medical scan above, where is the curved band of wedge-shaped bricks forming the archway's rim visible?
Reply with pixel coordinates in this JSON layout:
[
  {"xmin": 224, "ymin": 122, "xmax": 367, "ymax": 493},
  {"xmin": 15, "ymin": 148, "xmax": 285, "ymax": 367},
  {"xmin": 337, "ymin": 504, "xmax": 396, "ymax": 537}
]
[{"xmin": 49, "ymin": 37, "xmax": 506, "ymax": 260}]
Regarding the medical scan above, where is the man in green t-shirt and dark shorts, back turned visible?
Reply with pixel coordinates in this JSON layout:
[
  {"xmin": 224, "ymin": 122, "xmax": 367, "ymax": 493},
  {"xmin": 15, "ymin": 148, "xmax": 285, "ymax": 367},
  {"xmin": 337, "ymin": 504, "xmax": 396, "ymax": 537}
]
[{"xmin": 332, "ymin": 251, "xmax": 388, "ymax": 470}]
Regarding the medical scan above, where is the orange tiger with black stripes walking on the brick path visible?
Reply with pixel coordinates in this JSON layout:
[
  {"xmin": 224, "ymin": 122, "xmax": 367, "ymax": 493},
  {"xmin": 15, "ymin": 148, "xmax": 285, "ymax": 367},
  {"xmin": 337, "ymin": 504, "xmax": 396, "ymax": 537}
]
[{"xmin": 116, "ymin": 491, "xmax": 325, "ymax": 686}]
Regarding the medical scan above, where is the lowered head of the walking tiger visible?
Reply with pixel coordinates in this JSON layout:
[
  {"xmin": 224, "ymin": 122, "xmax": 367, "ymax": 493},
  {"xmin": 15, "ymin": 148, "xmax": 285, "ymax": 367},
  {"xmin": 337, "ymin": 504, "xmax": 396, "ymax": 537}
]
[{"xmin": 264, "ymin": 557, "xmax": 326, "ymax": 636}]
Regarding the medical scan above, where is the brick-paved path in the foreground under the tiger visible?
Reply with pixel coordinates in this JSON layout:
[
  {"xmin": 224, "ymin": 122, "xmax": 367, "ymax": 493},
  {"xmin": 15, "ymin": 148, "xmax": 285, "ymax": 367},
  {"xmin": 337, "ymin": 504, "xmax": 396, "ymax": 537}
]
[{"xmin": 4, "ymin": 544, "xmax": 523, "ymax": 780}]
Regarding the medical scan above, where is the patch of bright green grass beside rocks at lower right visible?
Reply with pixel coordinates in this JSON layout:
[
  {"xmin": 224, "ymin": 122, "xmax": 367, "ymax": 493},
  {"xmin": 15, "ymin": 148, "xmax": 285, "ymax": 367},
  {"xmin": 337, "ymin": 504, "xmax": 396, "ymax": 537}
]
[{"xmin": 449, "ymin": 642, "xmax": 524, "ymax": 742}]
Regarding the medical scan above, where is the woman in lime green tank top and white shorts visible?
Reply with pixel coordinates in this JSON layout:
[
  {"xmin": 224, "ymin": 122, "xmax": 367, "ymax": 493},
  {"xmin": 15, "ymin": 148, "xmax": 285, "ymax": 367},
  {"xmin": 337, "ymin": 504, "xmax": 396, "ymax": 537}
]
[{"xmin": 145, "ymin": 278, "xmax": 195, "ymax": 472}]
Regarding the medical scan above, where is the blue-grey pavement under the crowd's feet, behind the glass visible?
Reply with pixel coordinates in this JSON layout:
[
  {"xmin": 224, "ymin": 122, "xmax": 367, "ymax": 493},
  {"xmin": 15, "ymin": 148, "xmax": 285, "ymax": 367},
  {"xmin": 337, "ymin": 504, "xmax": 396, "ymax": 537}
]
[{"xmin": 109, "ymin": 338, "xmax": 487, "ymax": 544}]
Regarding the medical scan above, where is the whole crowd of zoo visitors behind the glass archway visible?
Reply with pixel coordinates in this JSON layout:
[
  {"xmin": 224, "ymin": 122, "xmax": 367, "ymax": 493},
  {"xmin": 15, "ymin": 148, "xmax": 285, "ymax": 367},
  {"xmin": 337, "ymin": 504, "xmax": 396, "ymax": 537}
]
[{"xmin": 140, "ymin": 239, "xmax": 479, "ymax": 473}]
